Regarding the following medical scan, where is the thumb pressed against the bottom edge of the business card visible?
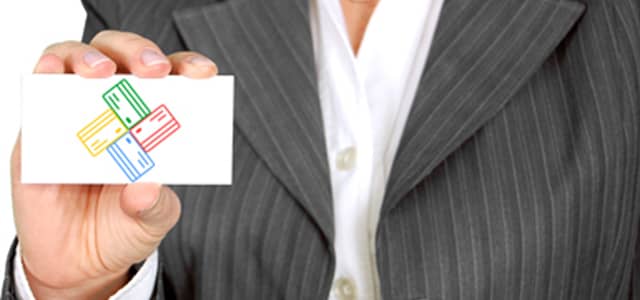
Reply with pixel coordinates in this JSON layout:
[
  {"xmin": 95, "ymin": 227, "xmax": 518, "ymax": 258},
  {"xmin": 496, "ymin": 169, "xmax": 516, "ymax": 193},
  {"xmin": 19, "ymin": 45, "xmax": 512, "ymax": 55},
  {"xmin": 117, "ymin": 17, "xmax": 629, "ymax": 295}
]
[{"xmin": 120, "ymin": 183, "xmax": 180, "ymax": 237}]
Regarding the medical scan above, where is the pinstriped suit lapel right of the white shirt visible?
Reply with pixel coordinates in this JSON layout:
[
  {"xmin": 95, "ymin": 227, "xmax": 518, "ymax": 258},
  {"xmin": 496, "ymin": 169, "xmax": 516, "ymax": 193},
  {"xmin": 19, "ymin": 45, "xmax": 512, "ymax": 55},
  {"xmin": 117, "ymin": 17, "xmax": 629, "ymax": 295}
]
[{"xmin": 382, "ymin": 0, "xmax": 584, "ymax": 214}]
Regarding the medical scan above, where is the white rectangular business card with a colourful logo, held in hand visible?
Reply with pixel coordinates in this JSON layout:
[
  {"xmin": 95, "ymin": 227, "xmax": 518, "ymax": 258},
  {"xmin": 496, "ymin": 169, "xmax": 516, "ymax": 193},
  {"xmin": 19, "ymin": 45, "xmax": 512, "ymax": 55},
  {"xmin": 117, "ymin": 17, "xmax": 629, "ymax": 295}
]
[{"xmin": 22, "ymin": 75, "xmax": 233, "ymax": 185}]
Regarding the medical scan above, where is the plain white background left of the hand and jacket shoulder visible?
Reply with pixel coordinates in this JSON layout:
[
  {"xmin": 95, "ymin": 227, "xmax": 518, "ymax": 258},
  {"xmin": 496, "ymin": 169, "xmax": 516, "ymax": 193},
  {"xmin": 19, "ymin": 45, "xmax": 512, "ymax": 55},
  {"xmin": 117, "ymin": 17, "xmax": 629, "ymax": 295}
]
[{"xmin": 0, "ymin": 0, "xmax": 85, "ymax": 276}]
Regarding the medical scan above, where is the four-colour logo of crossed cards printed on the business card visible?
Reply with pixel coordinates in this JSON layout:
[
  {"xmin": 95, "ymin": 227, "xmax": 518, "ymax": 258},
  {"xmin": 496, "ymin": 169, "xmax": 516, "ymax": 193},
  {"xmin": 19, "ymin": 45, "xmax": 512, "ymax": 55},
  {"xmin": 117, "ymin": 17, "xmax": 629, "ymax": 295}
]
[{"xmin": 77, "ymin": 79, "xmax": 180, "ymax": 182}]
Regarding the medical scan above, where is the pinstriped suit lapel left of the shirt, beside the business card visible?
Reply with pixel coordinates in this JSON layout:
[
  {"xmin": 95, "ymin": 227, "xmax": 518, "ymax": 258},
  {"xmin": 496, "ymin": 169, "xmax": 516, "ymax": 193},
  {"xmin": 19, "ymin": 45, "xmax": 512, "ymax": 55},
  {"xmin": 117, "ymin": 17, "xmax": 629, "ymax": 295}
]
[{"xmin": 174, "ymin": 0, "xmax": 333, "ymax": 244}]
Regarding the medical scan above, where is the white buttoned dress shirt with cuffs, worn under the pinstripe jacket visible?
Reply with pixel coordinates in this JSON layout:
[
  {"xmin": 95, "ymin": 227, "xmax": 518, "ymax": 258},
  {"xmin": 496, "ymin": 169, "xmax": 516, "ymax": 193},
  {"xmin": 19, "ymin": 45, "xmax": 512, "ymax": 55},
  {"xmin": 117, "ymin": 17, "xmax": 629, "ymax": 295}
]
[{"xmin": 15, "ymin": 0, "xmax": 444, "ymax": 300}]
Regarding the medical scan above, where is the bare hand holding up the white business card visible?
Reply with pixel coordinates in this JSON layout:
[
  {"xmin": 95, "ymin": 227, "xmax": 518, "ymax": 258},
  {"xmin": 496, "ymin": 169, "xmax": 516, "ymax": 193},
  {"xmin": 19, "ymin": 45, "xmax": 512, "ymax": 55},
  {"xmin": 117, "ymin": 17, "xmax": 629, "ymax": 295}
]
[{"xmin": 11, "ymin": 31, "xmax": 217, "ymax": 299}]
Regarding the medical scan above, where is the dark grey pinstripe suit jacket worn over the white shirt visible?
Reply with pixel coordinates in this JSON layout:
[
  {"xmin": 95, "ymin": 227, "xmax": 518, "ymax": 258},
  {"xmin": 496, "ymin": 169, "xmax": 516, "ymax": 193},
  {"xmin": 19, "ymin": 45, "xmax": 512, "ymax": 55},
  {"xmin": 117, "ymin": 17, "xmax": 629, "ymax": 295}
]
[{"xmin": 3, "ymin": 0, "xmax": 640, "ymax": 300}]
